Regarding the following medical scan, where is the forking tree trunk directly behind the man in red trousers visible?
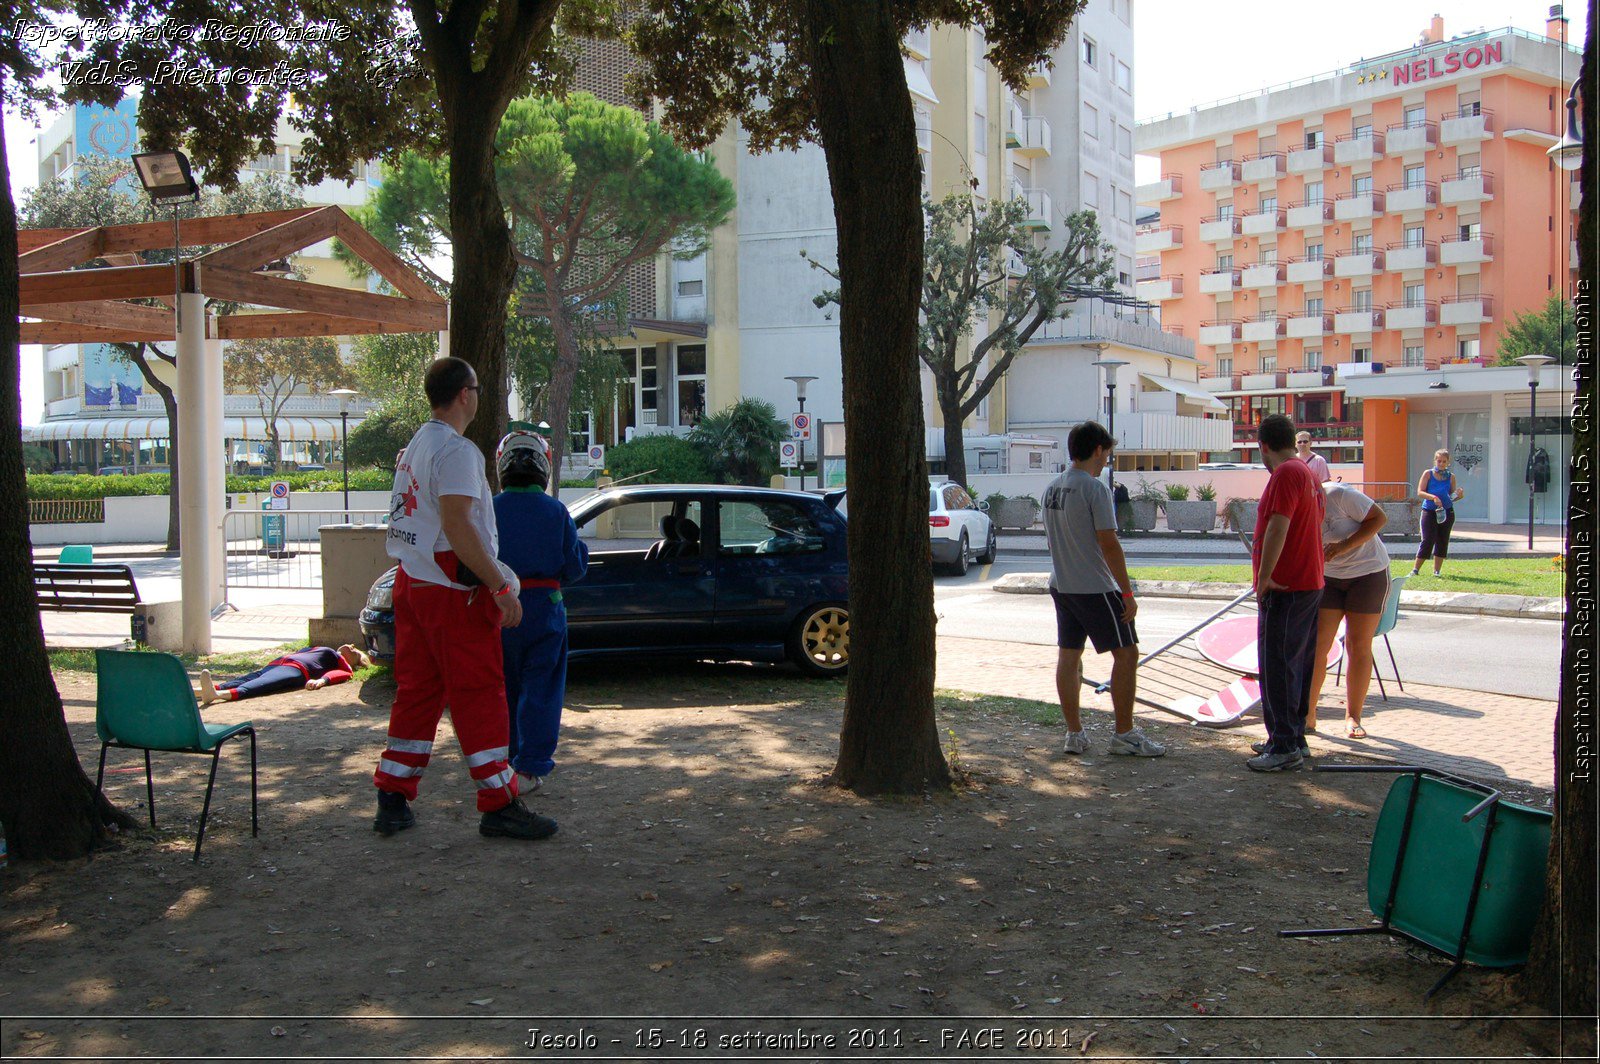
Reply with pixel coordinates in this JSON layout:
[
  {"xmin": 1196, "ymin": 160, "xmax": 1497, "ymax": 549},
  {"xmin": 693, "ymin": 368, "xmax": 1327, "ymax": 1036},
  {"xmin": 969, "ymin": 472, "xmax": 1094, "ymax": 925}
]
[{"xmin": 445, "ymin": 109, "xmax": 517, "ymax": 483}]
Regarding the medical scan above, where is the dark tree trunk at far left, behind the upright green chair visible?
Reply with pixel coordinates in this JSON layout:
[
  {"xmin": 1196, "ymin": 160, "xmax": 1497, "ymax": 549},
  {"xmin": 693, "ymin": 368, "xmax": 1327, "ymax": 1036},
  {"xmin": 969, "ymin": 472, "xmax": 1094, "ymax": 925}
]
[{"xmin": 0, "ymin": 120, "xmax": 133, "ymax": 859}]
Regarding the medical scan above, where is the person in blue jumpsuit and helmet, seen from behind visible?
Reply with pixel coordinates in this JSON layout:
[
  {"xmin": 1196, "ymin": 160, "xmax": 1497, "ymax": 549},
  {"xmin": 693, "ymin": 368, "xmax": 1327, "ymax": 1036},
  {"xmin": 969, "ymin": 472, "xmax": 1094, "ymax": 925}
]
[{"xmin": 494, "ymin": 432, "xmax": 589, "ymax": 794}]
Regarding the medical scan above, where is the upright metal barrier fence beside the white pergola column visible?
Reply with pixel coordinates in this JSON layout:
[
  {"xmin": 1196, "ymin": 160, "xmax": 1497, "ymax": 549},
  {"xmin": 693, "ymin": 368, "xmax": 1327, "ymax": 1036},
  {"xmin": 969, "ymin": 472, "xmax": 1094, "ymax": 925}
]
[{"xmin": 222, "ymin": 509, "xmax": 389, "ymax": 602}]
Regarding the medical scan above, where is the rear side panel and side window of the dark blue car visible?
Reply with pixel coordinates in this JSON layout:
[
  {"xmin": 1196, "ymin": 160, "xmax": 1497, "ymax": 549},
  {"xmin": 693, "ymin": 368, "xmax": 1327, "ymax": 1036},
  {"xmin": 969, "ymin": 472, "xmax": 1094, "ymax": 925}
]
[{"xmin": 715, "ymin": 494, "xmax": 848, "ymax": 643}]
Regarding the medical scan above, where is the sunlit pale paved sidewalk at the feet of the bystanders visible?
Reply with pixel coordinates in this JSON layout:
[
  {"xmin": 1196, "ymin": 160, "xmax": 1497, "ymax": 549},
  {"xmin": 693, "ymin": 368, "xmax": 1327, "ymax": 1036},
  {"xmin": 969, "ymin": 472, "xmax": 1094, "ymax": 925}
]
[{"xmin": 936, "ymin": 635, "xmax": 1555, "ymax": 790}]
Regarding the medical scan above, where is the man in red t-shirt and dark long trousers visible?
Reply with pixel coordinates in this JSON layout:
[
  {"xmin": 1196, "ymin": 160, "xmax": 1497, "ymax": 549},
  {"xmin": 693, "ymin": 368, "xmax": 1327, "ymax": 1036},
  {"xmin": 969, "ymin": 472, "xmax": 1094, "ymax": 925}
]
[{"xmin": 1246, "ymin": 414, "xmax": 1323, "ymax": 773}]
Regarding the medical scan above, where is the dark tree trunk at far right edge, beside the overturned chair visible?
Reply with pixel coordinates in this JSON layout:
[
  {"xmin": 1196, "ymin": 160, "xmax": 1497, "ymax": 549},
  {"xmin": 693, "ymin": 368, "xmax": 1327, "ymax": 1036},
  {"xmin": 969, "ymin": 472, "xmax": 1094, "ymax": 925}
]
[{"xmin": 1518, "ymin": 14, "xmax": 1600, "ymax": 1059}]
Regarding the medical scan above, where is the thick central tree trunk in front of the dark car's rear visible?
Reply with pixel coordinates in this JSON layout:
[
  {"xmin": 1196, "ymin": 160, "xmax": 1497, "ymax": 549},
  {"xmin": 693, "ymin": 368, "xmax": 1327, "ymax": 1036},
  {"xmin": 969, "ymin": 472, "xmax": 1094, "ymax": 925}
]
[{"xmin": 805, "ymin": 0, "xmax": 950, "ymax": 794}]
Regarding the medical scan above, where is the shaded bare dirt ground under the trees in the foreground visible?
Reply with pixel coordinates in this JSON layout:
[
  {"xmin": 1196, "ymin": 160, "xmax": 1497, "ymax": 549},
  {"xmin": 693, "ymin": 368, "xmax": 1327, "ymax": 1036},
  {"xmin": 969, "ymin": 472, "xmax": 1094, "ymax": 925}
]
[{"xmin": 0, "ymin": 666, "xmax": 1552, "ymax": 1059}]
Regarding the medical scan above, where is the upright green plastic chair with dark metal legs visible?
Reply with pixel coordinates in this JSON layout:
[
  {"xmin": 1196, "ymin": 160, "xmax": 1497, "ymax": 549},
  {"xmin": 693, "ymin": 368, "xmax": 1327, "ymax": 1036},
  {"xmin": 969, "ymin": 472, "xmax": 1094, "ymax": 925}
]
[{"xmin": 94, "ymin": 650, "xmax": 261, "ymax": 861}]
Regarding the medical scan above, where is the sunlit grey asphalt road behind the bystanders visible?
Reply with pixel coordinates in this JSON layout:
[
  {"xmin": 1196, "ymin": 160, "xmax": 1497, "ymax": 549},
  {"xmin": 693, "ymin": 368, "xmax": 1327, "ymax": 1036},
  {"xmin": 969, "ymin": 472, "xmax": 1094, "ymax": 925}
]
[{"xmin": 934, "ymin": 557, "xmax": 1562, "ymax": 699}]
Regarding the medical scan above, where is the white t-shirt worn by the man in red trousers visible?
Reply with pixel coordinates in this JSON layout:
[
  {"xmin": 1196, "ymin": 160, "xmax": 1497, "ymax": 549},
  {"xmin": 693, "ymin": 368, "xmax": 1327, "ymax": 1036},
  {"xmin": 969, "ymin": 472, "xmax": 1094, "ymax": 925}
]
[{"xmin": 387, "ymin": 419, "xmax": 499, "ymax": 589}]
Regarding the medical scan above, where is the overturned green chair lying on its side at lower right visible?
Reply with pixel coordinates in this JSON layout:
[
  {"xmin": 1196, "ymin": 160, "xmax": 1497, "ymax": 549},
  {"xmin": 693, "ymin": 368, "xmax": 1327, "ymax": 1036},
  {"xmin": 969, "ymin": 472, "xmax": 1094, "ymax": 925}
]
[{"xmin": 1278, "ymin": 765, "xmax": 1550, "ymax": 997}]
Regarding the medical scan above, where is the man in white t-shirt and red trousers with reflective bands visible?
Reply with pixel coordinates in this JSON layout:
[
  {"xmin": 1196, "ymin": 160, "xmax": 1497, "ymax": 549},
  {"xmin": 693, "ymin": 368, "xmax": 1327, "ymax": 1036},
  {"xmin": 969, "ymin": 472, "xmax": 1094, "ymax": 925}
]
[{"xmin": 373, "ymin": 358, "xmax": 557, "ymax": 840}]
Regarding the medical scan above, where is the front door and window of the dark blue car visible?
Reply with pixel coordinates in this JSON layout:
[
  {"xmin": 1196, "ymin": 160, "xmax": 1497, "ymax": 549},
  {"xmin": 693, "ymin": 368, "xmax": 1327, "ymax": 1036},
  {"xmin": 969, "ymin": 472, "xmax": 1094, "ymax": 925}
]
[{"xmin": 563, "ymin": 494, "xmax": 717, "ymax": 650}]
